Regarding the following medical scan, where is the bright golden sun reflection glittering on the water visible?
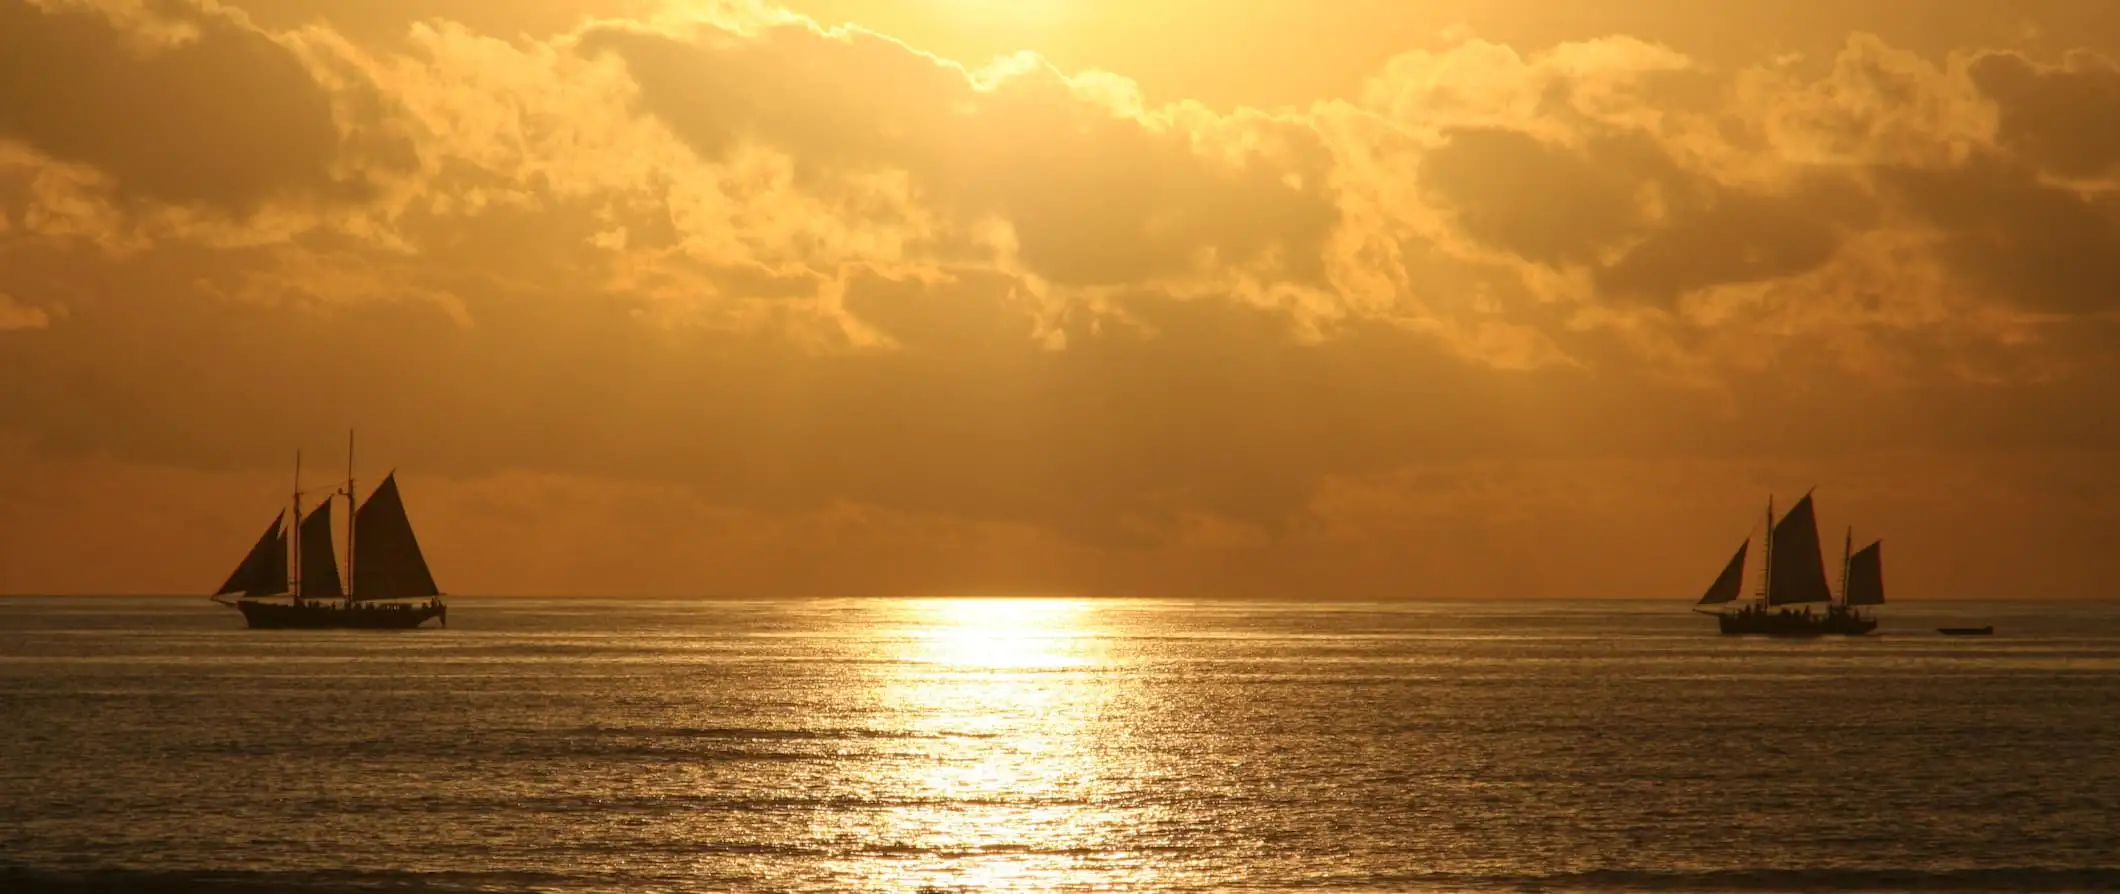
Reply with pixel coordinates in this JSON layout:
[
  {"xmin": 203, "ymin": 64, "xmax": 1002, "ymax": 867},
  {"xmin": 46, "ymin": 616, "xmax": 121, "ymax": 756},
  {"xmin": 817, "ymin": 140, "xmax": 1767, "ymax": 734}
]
[{"xmin": 840, "ymin": 600, "xmax": 1145, "ymax": 890}]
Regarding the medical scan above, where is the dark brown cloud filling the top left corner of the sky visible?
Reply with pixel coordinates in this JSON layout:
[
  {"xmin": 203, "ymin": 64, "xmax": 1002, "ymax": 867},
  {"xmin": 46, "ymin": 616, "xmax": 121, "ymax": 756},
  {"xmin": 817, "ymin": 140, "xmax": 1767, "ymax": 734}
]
[{"xmin": 0, "ymin": 0, "xmax": 405, "ymax": 212}]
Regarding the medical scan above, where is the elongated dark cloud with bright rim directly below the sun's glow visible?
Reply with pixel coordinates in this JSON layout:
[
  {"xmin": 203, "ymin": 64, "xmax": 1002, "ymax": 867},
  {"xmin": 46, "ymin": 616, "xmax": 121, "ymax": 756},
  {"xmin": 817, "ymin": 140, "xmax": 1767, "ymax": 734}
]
[{"xmin": 583, "ymin": 28, "xmax": 1338, "ymax": 284}]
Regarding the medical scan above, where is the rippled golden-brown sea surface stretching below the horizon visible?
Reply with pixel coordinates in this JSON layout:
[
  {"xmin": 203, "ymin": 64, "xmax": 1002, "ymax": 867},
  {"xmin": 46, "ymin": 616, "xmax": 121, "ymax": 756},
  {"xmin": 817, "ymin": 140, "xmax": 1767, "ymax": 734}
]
[{"xmin": 0, "ymin": 597, "xmax": 2120, "ymax": 894}]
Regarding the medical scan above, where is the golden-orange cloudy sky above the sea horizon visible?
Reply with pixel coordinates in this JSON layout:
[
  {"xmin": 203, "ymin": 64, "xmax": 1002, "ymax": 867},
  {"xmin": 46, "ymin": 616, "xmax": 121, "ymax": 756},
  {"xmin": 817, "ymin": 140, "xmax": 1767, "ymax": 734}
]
[{"xmin": 0, "ymin": 0, "xmax": 2120, "ymax": 602}]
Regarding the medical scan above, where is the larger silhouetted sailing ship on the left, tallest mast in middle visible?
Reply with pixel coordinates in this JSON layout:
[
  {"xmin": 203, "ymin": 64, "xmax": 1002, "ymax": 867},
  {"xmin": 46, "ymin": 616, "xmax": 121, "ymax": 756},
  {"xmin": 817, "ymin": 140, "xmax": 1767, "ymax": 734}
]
[{"xmin": 214, "ymin": 434, "xmax": 449, "ymax": 629}]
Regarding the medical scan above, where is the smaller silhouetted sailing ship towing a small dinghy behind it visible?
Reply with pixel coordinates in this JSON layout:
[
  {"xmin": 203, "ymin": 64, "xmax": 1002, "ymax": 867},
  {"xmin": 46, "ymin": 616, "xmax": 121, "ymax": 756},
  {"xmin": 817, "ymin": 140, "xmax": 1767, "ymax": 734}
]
[{"xmin": 1694, "ymin": 494, "xmax": 1885, "ymax": 636}]
